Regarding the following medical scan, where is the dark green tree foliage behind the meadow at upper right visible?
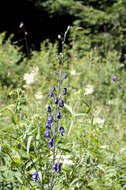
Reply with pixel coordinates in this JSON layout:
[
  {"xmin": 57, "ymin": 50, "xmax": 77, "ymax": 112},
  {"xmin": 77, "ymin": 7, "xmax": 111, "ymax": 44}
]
[{"xmin": 24, "ymin": 0, "xmax": 126, "ymax": 57}]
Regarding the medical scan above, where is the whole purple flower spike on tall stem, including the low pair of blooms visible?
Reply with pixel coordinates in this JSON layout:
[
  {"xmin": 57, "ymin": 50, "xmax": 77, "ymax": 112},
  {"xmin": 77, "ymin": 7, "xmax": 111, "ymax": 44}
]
[{"xmin": 45, "ymin": 72, "xmax": 68, "ymax": 177}]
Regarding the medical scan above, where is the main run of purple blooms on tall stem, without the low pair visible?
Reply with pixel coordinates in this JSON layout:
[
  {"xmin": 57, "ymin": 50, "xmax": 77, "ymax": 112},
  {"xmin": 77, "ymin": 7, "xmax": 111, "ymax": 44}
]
[{"xmin": 45, "ymin": 73, "xmax": 67, "ymax": 148}]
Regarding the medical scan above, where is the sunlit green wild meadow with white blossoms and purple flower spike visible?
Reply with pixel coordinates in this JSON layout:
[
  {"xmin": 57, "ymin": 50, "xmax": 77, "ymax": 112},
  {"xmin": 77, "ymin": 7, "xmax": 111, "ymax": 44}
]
[{"xmin": 0, "ymin": 27, "xmax": 126, "ymax": 190}]
